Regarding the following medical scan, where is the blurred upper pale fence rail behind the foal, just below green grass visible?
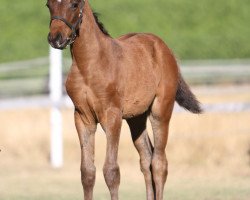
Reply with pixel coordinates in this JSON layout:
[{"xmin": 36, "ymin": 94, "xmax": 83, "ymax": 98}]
[{"xmin": 0, "ymin": 58, "xmax": 250, "ymax": 99}]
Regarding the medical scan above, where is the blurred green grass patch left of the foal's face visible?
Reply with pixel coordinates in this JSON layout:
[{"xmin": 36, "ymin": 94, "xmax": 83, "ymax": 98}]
[{"xmin": 0, "ymin": 0, "xmax": 48, "ymax": 62}]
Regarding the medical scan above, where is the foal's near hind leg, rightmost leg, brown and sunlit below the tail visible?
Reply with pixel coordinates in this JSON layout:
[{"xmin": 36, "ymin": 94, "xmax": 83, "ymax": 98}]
[{"xmin": 150, "ymin": 93, "xmax": 174, "ymax": 200}]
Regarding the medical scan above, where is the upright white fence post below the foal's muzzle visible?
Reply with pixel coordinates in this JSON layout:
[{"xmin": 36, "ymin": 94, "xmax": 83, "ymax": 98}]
[{"xmin": 49, "ymin": 47, "xmax": 63, "ymax": 168}]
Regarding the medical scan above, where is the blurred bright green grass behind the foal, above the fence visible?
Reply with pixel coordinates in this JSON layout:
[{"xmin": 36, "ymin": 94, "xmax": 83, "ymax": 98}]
[{"xmin": 0, "ymin": 0, "xmax": 250, "ymax": 63}]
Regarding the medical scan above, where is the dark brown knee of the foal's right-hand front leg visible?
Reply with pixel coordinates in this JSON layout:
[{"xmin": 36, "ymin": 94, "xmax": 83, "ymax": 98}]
[{"xmin": 103, "ymin": 164, "xmax": 120, "ymax": 188}]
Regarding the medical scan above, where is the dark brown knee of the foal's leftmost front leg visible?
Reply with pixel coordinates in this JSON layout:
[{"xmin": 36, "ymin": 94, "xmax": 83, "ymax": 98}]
[{"xmin": 81, "ymin": 166, "xmax": 96, "ymax": 188}]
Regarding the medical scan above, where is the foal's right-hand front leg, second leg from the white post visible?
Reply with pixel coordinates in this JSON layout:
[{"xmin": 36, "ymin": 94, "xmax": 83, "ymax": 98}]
[{"xmin": 101, "ymin": 108, "xmax": 122, "ymax": 200}]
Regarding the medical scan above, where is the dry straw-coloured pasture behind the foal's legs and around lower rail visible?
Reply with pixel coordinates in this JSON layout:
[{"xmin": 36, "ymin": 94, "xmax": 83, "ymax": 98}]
[{"xmin": 0, "ymin": 85, "xmax": 250, "ymax": 200}]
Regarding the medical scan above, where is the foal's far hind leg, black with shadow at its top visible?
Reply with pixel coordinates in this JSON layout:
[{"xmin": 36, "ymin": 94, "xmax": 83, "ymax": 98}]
[{"xmin": 127, "ymin": 113, "xmax": 155, "ymax": 200}]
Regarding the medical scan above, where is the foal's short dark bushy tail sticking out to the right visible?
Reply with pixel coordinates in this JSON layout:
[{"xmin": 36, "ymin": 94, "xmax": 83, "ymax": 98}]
[{"xmin": 175, "ymin": 73, "xmax": 202, "ymax": 114}]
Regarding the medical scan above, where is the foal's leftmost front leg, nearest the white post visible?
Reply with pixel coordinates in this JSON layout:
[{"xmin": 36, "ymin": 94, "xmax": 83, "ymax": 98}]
[{"xmin": 75, "ymin": 111, "xmax": 96, "ymax": 200}]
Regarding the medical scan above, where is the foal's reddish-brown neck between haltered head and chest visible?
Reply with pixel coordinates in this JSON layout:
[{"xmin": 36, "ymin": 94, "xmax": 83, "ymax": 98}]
[{"xmin": 72, "ymin": 0, "xmax": 111, "ymax": 67}]
